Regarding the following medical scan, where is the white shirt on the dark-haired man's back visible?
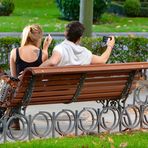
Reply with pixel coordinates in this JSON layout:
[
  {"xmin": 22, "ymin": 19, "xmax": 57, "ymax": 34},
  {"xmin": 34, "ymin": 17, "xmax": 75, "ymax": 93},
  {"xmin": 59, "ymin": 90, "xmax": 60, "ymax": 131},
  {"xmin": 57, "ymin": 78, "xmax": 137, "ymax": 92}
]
[{"xmin": 53, "ymin": 39, "xmax": 92, "ymax": 66}]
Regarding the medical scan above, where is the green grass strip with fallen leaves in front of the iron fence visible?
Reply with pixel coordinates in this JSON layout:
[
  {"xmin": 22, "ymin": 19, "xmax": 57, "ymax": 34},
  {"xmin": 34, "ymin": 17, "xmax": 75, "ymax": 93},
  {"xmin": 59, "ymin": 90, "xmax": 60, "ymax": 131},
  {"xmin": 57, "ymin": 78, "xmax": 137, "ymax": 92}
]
[{"xmin": 0, "ymin": 132, "xmax": 148, "ymax": 148}]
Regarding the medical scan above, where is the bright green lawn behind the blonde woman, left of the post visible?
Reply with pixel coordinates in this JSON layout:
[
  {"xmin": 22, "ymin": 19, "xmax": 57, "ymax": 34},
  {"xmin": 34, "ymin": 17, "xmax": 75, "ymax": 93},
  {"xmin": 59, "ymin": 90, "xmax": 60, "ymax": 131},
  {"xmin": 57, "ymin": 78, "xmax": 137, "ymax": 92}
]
[{"xmin": 0, "ymin": 0, "xmax": 67, "ymax": 32}]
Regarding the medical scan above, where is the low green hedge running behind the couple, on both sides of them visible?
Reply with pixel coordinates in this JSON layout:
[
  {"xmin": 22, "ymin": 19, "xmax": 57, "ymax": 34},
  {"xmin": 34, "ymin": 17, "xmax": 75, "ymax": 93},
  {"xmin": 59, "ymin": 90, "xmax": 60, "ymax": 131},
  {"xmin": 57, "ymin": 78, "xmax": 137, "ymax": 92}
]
[{"xmin": 0, "ymin": 37, "xmax": 148, "ymax": 69}]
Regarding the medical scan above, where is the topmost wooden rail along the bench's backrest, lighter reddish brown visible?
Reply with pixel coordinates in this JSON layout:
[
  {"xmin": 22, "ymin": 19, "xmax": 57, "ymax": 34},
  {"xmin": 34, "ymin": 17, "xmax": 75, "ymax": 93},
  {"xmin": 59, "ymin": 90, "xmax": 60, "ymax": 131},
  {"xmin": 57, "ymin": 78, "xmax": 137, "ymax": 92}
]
[{"xmin": 23, "ymin": 62, "xmax": 148, "ymax": 75}]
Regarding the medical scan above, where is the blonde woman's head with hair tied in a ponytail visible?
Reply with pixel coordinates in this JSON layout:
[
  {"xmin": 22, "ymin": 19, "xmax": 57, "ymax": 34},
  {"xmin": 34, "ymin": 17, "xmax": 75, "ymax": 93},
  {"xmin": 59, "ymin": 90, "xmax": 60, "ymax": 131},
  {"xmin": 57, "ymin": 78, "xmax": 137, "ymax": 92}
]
[{"xmin": 21, "ymin": 24, "xmax": 43, "ymax": 47}]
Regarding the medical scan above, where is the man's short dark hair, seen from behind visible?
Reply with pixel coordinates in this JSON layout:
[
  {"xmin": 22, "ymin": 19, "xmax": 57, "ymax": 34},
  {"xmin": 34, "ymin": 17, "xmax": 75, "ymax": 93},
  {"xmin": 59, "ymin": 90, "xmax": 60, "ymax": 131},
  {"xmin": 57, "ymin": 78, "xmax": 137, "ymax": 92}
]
[{"xmin": 66, "ymin": 21, "xmax": 85, "ymax": 43}]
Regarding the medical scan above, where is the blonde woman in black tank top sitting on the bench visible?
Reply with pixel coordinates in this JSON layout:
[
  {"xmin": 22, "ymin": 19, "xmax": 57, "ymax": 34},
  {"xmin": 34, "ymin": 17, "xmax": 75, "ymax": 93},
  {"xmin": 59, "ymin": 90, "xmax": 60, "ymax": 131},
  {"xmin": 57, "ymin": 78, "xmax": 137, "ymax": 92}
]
[{"xmin": 10, "ymin": 24, "xmax": 52, "ymax": 77}]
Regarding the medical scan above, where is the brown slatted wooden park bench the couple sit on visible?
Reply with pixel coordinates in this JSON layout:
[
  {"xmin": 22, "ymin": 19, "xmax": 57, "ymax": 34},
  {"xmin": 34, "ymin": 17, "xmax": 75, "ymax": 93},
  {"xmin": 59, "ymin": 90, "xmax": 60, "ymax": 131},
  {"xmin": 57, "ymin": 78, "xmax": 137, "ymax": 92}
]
[{"xmin": 0, "ymin": 62, "xmax": 148, "ymax": 117}]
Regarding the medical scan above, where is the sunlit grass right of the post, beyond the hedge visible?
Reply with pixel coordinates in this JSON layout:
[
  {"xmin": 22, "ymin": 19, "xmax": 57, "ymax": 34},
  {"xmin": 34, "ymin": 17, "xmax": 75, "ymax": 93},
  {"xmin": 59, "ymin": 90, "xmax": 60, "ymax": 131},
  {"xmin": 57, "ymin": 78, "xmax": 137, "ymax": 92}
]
[{"xmin": 93, "ymin": 13, "xmax": 148, "ymax": 32}]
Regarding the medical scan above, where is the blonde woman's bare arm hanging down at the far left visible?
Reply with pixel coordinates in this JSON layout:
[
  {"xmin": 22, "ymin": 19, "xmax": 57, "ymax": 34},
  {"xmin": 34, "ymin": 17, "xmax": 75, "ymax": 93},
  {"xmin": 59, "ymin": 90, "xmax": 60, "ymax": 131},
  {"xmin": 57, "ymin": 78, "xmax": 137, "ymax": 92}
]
[{"xmin": 10, "ymin": 49, "xmax": 17, "ymax": 77}]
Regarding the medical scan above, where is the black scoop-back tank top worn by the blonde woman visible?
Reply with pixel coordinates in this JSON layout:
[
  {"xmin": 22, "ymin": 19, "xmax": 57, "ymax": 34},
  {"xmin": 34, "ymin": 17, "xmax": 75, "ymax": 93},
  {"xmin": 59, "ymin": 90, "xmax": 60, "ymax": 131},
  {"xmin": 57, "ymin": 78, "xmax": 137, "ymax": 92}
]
[{"xmin": 16, "ymin": 48, "xmax": 42, "ymax": 76}]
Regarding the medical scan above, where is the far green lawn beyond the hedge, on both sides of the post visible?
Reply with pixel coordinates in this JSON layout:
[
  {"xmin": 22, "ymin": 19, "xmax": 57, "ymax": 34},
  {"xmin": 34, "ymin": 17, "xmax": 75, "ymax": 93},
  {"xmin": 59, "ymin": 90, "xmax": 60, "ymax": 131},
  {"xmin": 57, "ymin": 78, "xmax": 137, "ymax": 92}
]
[{"xmin": 0, "ymin": 0, "xmax": 148, "ymax": 32}]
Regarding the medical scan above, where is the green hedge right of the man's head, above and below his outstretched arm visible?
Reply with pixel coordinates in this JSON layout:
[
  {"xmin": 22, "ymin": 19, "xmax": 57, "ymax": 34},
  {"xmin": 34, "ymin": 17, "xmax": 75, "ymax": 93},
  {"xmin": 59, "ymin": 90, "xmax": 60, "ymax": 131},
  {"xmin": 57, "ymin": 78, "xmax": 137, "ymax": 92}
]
[{"xmin": 82, "ymin": 37, "xmax": 148, "ymax": 63}]
